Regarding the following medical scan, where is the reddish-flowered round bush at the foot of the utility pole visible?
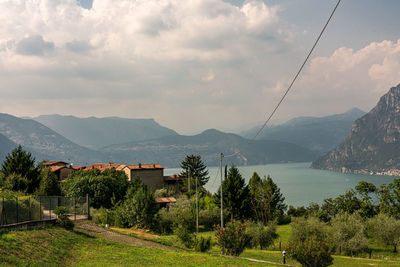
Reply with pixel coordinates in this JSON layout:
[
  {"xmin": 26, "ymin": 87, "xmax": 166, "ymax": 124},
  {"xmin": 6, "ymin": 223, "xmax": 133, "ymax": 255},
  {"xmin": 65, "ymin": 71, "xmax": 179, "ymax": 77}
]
[{"xmin": 215, "ymin": 221, "xmax": 250, "ymax": 256}]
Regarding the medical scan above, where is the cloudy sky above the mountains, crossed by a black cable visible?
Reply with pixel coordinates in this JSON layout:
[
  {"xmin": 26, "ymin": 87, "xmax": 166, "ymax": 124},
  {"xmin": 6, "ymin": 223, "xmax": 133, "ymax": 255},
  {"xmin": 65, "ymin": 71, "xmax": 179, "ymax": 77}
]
[{"xmin": 0, "ymin": 0, "xmax": 400, "ymax": 134}]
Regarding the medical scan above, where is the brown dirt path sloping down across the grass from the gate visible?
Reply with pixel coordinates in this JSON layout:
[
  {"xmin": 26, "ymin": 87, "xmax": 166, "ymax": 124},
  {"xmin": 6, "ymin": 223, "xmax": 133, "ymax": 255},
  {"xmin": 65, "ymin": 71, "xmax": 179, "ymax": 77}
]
[{"xmin": 74, "ymin": 220, "xmax": 182, "ymax": 251}]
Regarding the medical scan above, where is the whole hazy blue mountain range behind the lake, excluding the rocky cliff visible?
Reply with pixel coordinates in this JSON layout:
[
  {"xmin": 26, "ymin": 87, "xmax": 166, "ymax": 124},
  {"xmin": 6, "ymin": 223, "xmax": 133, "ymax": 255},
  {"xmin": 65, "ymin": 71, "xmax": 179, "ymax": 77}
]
[{"xmin": 0, "ymin": 109, "xmax": 363, "ymax": 167}]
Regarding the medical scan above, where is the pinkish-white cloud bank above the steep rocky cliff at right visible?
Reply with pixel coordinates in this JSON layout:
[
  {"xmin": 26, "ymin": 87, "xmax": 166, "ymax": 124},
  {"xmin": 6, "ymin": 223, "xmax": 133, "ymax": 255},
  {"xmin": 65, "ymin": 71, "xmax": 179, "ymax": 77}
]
[{"xmin": 280, "ymin": 40, "xmax": 400, "ymax": 114}]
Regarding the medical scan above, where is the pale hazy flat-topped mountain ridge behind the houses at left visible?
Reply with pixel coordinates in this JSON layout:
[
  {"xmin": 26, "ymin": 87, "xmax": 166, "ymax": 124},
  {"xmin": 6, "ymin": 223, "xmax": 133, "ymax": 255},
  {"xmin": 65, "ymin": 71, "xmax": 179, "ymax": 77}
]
[{"xmin": 33, "ymin": 115, "xmax": 177, "ymax": 149}]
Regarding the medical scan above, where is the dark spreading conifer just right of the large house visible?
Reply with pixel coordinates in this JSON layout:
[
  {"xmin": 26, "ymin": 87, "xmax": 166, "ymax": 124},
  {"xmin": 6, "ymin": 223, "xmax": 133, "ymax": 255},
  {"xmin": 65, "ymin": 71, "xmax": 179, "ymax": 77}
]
[{"xmin": 180, "ymin": 155, "xmax": 210, "ymax": 194}]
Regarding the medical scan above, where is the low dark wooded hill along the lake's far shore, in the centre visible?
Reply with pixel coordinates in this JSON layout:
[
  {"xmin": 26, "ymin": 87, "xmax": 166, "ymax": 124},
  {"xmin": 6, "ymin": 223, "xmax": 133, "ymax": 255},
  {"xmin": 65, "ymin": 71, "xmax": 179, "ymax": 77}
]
[{"xmin": 102, "ymin": 130, "xmax": 317, "ymax": 167}]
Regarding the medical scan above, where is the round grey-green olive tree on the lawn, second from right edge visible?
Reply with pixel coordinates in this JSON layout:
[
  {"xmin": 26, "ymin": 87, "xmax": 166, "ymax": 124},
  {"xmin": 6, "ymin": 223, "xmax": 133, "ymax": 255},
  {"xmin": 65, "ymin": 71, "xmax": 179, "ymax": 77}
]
[{"xmin": 332, "ymin": 213, "xmax": 368, "ymax": 256}]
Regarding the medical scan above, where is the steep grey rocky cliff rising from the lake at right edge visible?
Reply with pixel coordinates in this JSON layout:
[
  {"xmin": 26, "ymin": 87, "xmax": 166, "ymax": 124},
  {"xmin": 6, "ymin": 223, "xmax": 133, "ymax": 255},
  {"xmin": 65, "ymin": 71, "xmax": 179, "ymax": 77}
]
[{"xmin": 312, "ymin": 84, "xmax": 400, "ymax": 175}]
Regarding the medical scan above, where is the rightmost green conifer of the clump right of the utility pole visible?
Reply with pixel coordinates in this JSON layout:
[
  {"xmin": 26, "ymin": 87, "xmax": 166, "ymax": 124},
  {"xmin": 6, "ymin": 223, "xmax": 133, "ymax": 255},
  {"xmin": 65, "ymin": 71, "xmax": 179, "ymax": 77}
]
[{"xmin": 249, "ymin": 172, "xmax": 287, "ymax": 225}]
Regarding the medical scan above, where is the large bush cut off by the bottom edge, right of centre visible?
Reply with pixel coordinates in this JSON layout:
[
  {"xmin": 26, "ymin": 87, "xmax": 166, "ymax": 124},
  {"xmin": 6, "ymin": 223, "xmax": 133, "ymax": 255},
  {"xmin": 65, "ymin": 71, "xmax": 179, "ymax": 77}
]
[{"xmin": 287, "ymin": 236, "xmax": 333, "ymax": 267}]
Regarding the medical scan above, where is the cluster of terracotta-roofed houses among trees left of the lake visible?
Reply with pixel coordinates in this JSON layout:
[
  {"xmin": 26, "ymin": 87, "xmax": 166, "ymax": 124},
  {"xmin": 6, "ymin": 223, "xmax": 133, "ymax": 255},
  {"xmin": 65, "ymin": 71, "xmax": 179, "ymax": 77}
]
[{"xmin": 43, "ymin": 161, "xmax": 182, "ymax": 203}]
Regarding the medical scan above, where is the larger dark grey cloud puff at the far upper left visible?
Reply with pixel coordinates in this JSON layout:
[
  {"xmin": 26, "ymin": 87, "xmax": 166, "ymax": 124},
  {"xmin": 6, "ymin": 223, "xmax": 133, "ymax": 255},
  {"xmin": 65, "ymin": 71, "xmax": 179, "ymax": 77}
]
[{"xmin": 16, "ymin": 35, "xmax": 54, "ymax": 56}]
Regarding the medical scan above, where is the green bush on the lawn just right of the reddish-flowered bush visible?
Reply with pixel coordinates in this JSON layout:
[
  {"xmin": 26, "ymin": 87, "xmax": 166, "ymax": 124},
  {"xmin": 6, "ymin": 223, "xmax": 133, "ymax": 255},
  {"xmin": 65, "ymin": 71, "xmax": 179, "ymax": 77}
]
[{"xmin": 247, "ymin": 222, "xmax": 278, "ymax": 249}]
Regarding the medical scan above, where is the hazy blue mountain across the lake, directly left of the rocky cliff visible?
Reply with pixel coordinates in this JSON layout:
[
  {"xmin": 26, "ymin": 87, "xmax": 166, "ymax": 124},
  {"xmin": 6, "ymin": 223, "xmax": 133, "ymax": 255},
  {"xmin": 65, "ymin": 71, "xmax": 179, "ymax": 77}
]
[{"xmin": 241, "ymin": 108, "xmax": 365, "ymax": 155}]
